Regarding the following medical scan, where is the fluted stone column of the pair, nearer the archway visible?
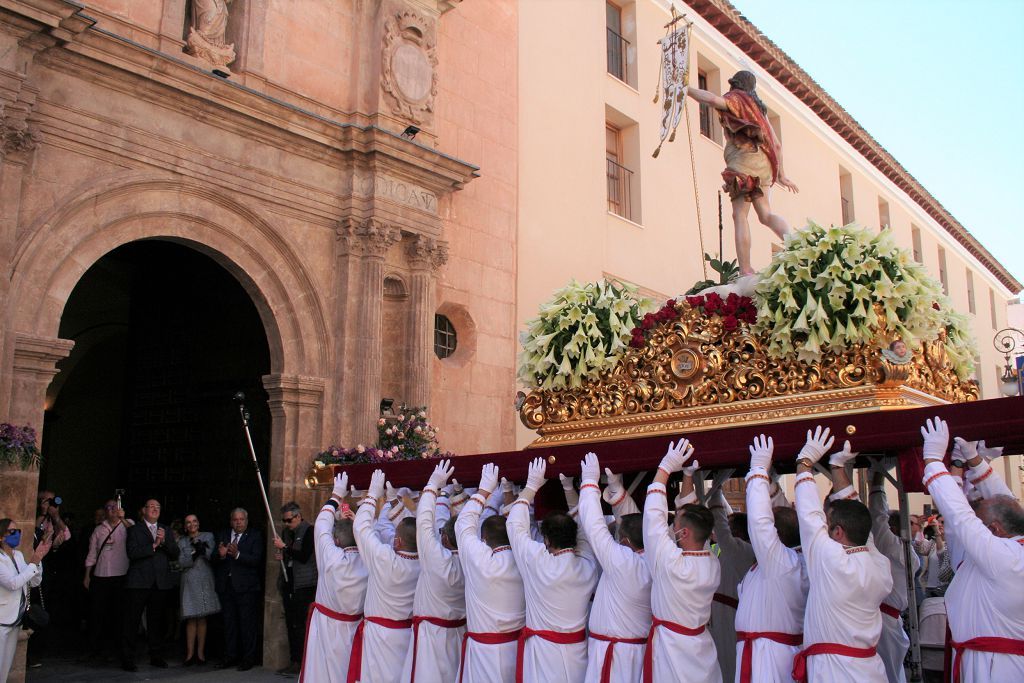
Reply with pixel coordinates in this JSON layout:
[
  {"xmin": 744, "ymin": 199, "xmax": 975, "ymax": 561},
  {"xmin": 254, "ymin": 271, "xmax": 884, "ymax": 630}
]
[{"xmin": 349, "ymin": 218, "xmax": 401, "ymax": 444}]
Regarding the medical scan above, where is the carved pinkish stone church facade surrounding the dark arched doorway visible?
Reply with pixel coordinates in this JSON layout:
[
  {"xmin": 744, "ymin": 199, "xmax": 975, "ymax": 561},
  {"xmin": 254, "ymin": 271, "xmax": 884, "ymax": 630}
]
[{"xmin": 0, "ymin": 0, "xmax": 517, "ymax": 666}]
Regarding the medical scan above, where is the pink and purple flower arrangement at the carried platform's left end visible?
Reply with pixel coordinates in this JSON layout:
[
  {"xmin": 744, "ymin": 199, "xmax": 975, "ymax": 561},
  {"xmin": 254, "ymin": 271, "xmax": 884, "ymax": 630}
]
[{"xmin": 313, "ymin": 405, "xmax": 452, "ymax": 467}]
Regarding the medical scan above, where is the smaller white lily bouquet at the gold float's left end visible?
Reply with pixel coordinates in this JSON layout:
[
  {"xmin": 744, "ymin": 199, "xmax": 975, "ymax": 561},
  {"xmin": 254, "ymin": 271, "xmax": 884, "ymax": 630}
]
[{"xmin": 518, "ymin": 280, "xmax": 651, "ymax": 389}]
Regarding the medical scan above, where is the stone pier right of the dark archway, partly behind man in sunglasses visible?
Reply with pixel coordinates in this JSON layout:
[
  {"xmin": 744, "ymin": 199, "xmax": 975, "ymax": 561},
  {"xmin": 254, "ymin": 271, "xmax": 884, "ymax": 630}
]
[{"xmin": 260, "ymin": 374, "xmax": 326, "ymax": 669}]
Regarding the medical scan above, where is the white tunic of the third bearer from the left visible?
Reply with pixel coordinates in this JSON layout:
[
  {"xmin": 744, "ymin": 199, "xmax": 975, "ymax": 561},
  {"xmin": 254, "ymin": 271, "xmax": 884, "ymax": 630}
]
[{"xmin": 402, "ymin": 488, "xmax": 466, "ymax": 683}]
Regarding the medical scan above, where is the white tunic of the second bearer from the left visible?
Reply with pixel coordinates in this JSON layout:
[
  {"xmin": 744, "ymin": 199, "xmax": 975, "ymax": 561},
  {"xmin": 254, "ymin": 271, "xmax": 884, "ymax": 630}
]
[{"xmin": 354, "ymin": 499, "xmax": 420, "ymax": 683}]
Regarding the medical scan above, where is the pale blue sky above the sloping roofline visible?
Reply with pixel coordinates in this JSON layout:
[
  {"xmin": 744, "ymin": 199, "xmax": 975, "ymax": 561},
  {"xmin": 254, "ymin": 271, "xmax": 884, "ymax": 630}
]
[{"xmin": 732, "ymin": 0, "xmax": 1024, "ymax": 294}]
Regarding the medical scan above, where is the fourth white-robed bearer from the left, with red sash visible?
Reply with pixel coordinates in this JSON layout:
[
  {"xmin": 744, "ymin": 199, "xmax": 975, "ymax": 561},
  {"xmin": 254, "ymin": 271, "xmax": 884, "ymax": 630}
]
[{"xmin": 455, "ymin": 464, "xmax": 526, "ymax": 683}]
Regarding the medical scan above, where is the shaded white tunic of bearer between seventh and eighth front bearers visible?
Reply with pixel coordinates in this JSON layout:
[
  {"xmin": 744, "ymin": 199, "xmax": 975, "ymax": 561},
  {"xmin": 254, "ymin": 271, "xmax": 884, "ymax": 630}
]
[{"xmin": 709, "ymin": 489, "xmax": 754, "ymax": 681}]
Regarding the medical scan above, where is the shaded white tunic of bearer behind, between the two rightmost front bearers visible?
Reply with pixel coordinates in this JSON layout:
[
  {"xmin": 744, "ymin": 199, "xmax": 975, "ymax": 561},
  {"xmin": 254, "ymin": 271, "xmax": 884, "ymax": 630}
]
[{"xmin": 867, "ymin": 486, "xmax": 921, "ymax": 683}]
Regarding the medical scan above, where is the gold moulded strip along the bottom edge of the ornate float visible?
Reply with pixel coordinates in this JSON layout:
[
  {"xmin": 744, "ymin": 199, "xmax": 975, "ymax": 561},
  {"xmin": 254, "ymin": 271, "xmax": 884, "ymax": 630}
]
[{"xmin": 526, "ymin": 384, "xmax": 949, "ymax": 449}]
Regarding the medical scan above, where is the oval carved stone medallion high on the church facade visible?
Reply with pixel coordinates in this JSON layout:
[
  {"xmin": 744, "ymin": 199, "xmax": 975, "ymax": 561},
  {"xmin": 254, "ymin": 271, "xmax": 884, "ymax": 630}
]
[{"xmin": 381, "ymin": 9, "xmax": 437, "ymax": 123}]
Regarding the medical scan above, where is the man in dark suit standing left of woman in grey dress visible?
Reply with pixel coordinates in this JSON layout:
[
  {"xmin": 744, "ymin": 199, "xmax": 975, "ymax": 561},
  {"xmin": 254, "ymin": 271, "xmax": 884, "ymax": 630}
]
[{"xmin": 121, "ymin": 500, "xmax": 181, "ymax": 671}]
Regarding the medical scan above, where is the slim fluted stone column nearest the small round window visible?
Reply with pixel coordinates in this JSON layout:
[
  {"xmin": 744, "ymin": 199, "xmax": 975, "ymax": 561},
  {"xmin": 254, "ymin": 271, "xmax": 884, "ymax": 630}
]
[{"xmin": 406, "ymin": 234, "xmax": 447, "ymax": 407}]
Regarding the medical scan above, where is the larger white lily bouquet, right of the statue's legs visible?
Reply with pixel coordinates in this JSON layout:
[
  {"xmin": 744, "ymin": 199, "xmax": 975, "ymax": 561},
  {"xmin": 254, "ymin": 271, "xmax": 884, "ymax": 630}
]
[{"xmin": 756, "ymin": 222, "xmax": 976, "ymax": 380}]
